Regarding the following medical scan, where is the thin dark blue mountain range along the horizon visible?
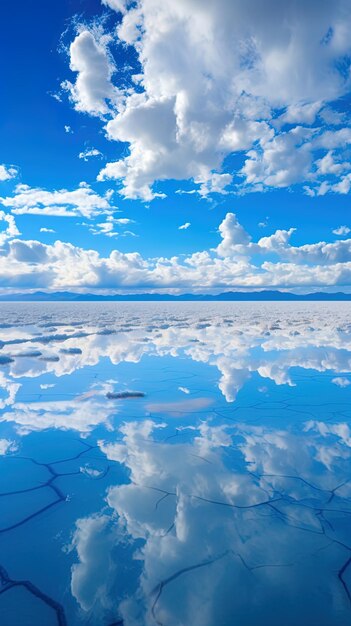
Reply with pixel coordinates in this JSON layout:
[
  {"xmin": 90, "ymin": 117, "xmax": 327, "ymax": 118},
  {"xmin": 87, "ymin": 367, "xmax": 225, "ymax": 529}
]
[{"xmin": 0, "ymin": 291, "xmax": 351, "ymax": 302}]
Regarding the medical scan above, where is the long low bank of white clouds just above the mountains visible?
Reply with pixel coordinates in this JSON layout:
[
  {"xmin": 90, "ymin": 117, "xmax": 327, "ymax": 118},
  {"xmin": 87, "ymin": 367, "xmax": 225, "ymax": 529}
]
[{"xmin": 0, "ymin": 213, "xmax": 351, "ymax": 289}]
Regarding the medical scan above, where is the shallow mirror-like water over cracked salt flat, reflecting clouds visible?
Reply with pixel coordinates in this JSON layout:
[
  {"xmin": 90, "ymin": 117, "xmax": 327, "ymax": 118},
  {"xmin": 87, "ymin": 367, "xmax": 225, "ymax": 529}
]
[{"xmin": 0, "ymin": 303, "xmax": 351, "ymax": 626}]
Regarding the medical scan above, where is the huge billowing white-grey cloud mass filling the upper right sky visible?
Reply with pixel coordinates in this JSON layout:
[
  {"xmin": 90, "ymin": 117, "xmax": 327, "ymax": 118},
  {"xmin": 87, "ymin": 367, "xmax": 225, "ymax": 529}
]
[{"xmin": 58, "ymin": 0, "xmax": 351, "ymax": 201}]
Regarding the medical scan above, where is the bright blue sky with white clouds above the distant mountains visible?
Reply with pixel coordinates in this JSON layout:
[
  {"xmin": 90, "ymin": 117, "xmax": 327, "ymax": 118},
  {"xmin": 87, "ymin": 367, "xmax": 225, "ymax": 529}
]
[{"xmin": 0, "ymin": 0, "xmax": 351, "ymax": 292}]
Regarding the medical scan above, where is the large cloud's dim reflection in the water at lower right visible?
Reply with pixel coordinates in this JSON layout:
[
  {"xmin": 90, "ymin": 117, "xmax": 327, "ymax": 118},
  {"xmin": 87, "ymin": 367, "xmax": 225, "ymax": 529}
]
[{"xmin": 69, "ymin": 410, "xmax": 350, "ymax": 626}]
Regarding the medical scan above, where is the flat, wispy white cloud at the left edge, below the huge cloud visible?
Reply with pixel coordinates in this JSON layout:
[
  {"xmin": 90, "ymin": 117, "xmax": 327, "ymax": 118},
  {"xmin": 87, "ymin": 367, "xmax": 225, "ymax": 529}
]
[{"xmin": 0, "ymin": 182, "xmax": 113, "ymax": 219}]
